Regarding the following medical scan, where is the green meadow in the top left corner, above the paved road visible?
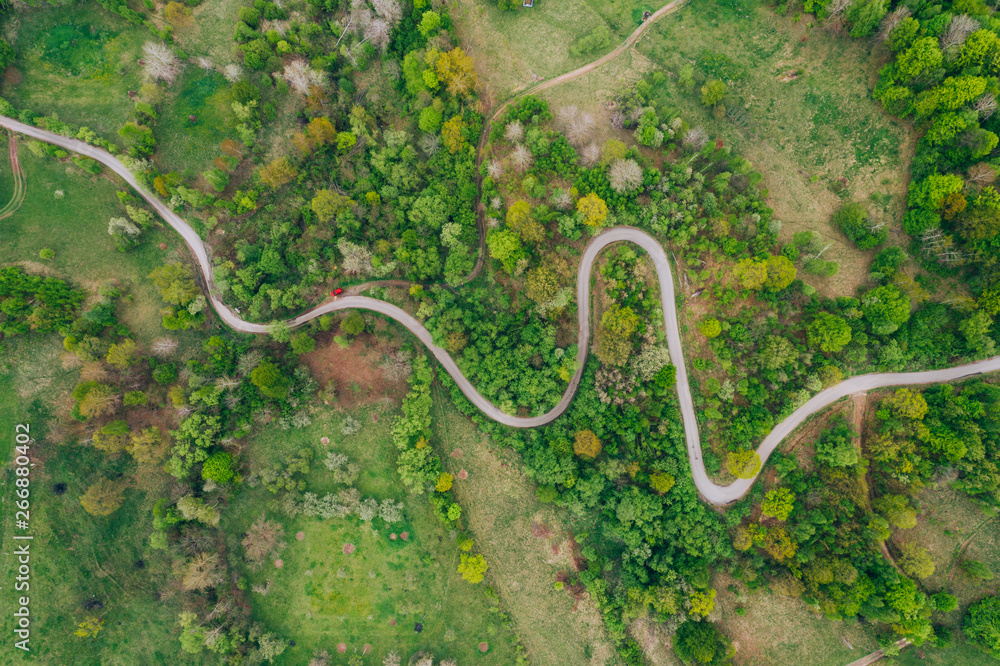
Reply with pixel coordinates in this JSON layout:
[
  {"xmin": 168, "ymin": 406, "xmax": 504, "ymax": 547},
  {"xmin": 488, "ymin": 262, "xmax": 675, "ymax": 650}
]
[{"xmin": 0, "ymin": 4, "xmax": 149, "ymax": 140}]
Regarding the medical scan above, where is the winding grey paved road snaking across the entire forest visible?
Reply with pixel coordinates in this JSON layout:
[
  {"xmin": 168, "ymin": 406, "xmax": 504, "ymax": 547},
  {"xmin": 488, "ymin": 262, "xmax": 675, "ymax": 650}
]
[{"xmin": 0, "ymin": 116, "xmax": 1000, "ymax": 505}]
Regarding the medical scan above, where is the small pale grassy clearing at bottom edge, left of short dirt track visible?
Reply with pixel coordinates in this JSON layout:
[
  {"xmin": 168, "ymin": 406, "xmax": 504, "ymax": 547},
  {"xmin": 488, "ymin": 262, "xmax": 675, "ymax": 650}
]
[{"xmin": 712, "ymin": 574, "xmax": 878, "ymax": 666}]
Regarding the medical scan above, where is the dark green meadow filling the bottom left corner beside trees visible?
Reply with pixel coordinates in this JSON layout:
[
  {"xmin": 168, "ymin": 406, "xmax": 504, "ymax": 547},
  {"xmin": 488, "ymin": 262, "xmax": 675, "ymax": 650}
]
[{"xmin": 0, "ymin": 348, "xmax": 198, "ymax": 666}]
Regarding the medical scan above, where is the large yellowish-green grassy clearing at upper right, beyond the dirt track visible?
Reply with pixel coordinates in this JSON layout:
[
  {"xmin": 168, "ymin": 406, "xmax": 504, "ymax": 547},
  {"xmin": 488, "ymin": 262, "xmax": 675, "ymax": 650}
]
[{"xmin": 638, "ymin": 0, "xmax": 912, "ymax": 294}]
